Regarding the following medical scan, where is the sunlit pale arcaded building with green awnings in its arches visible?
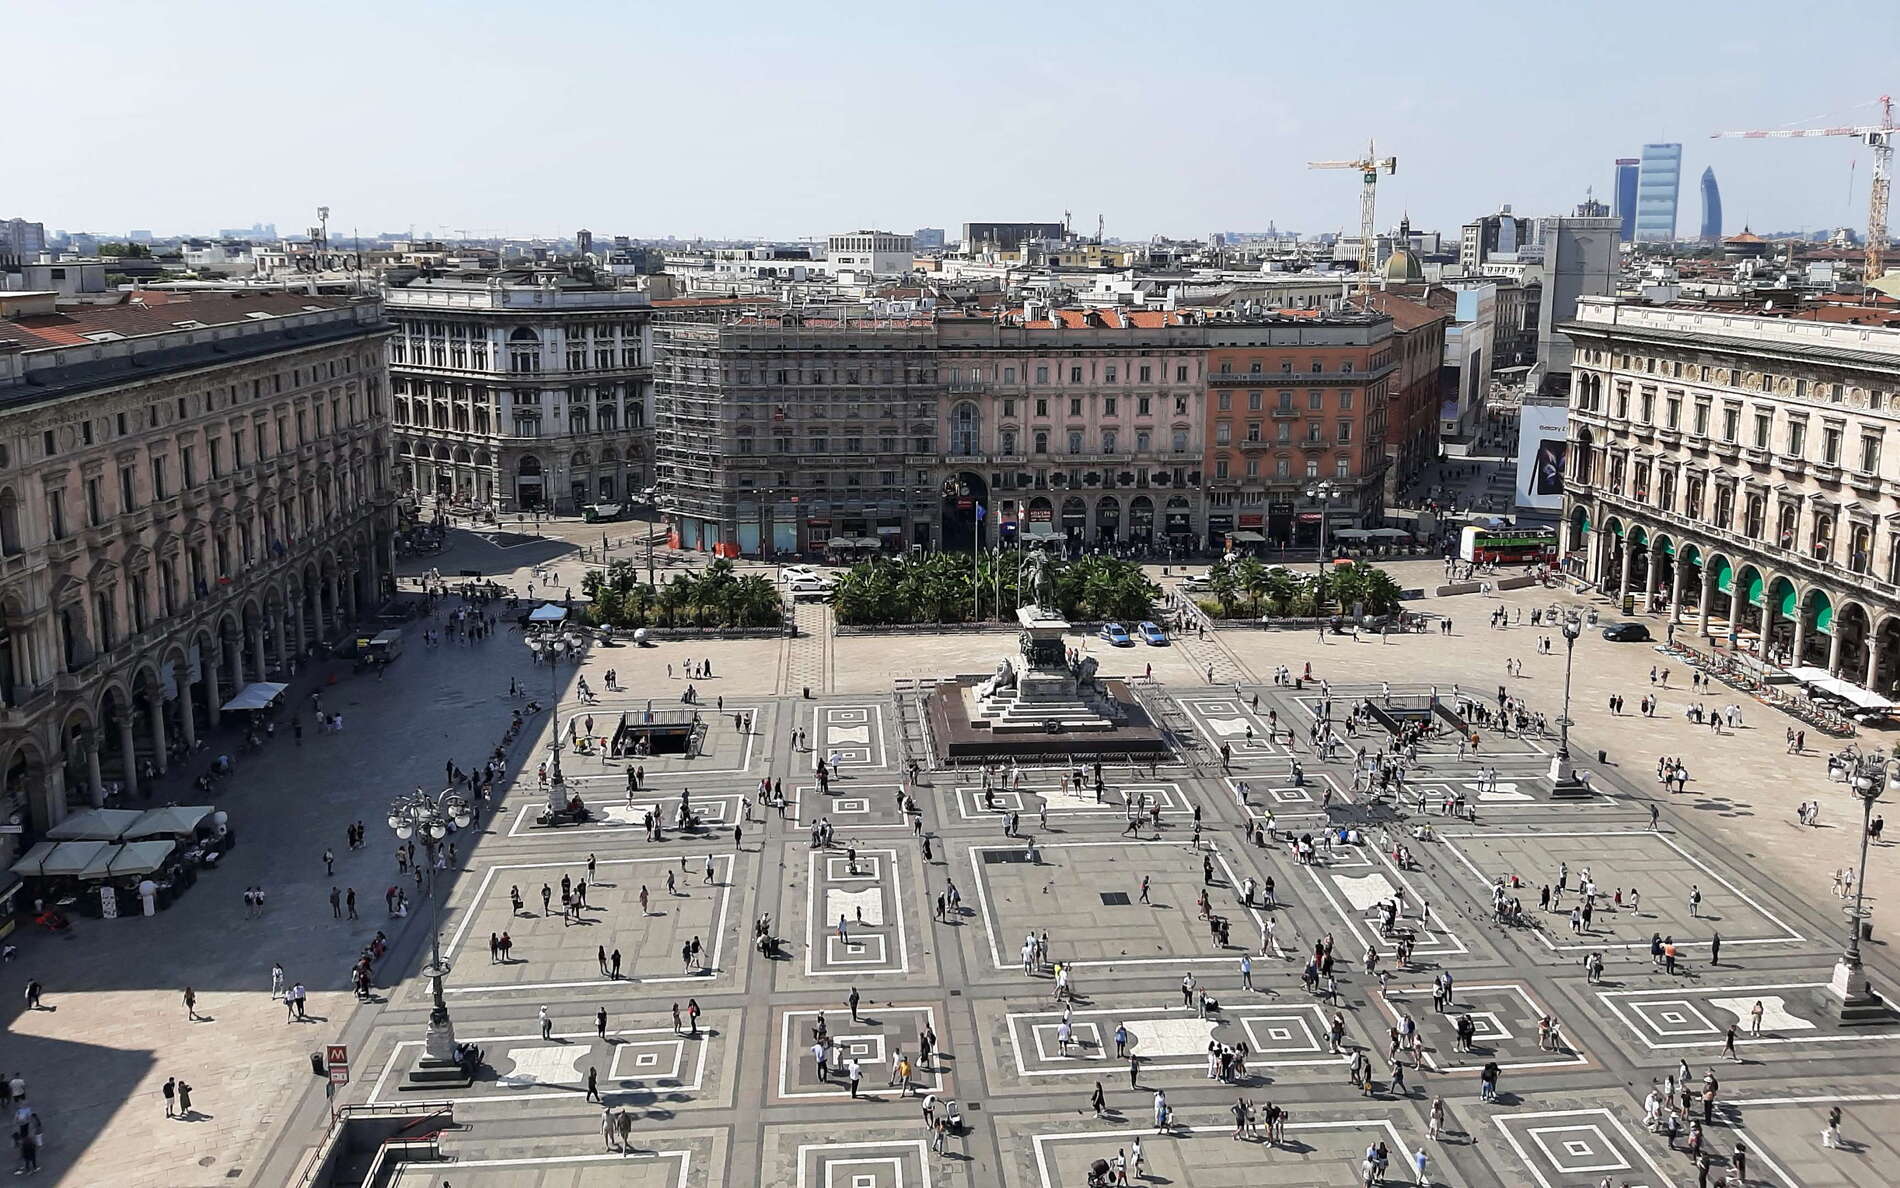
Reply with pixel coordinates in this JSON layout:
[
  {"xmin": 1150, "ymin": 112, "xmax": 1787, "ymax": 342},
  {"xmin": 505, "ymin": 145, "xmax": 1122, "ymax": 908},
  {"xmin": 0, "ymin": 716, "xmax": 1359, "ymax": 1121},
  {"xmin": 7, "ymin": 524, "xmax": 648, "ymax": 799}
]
[{"xmin": 1564, "ymin": 297, "xmax": 1900, "ymax": 696}]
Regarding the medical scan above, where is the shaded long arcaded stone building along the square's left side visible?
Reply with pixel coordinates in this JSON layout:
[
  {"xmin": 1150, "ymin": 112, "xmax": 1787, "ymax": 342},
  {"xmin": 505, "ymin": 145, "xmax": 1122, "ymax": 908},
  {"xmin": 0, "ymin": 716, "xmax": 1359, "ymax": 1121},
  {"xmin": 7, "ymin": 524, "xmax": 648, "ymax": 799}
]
[{"xmin": 0, "ymin": 293, "xmax": 393, "ymax": 840}]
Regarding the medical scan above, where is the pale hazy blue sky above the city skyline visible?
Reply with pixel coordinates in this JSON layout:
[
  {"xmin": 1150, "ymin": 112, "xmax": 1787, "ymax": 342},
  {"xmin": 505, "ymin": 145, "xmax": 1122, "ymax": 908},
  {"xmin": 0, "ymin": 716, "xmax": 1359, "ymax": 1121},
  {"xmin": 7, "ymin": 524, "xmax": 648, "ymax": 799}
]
[{"xmin": 14, "ymin": 0, "xmax": 1900, "ymax": 238}]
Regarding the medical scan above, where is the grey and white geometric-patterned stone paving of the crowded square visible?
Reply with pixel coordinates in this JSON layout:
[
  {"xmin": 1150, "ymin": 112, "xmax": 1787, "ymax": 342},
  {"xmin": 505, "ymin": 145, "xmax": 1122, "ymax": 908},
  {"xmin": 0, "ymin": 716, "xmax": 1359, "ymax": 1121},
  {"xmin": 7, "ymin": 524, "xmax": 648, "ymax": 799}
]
[{"xmin": 10, "ymin": 517, "xmax": 1900, "ymax": 1188}]
